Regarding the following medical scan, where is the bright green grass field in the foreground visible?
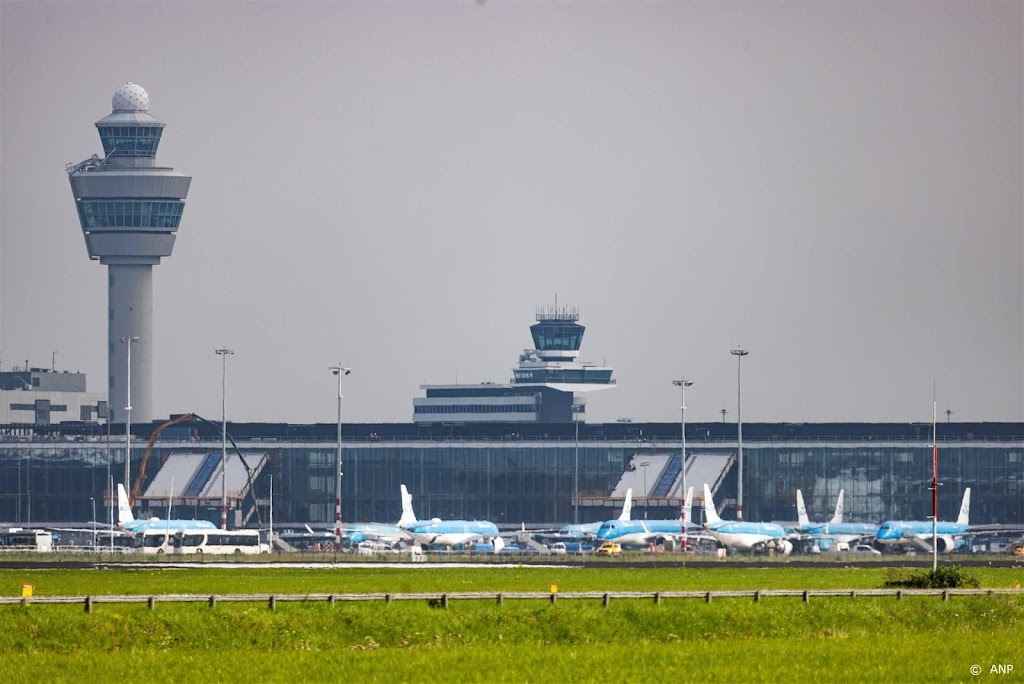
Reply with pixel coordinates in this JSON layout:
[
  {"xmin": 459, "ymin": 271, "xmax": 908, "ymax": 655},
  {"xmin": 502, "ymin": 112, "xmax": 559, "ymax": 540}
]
[{"xmin": 0, "ymin": 567, "xmax": 1024, "ymax": 682}]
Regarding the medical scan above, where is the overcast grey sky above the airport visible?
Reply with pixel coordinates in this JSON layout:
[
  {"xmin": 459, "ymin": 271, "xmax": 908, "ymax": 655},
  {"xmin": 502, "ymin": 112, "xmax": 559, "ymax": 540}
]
[{"xmin": 0, "ymin": 0, "xmax": 1024, "ymax": 422}]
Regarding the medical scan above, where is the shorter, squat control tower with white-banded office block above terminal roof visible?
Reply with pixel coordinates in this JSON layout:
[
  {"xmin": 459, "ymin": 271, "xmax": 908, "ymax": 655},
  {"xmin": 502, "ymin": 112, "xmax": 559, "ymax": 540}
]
[{"xmin": 413, "ymin": 307, "xmax": 615, "ymax": 424}]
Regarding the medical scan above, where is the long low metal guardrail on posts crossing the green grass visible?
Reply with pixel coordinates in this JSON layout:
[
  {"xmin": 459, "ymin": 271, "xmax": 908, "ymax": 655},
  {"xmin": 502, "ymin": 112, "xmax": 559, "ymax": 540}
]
[{"xmin": 0, "ymin": 589, "xmax": 1024, "ymax": 612}]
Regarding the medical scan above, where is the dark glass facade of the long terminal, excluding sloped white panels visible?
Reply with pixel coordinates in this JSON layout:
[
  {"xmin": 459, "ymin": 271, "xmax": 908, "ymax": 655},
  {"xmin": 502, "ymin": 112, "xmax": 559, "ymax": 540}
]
[{"xmin": 0, "ymin": 425, "xmax": 1024, "ymax": 525}]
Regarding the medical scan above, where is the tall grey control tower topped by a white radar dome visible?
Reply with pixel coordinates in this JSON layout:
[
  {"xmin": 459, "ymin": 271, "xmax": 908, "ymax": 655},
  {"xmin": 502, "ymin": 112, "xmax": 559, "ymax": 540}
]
[{"xmin": 68, "ymin": 83, "xmax": 191, "ymax": 423}]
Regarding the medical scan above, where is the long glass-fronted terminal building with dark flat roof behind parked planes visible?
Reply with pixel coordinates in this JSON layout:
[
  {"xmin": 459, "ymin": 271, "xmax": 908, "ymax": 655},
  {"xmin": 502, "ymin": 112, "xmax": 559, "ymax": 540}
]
[{"xmin": 0, "ymin": 419, "xmax": 1024, "ymax": 527}]
